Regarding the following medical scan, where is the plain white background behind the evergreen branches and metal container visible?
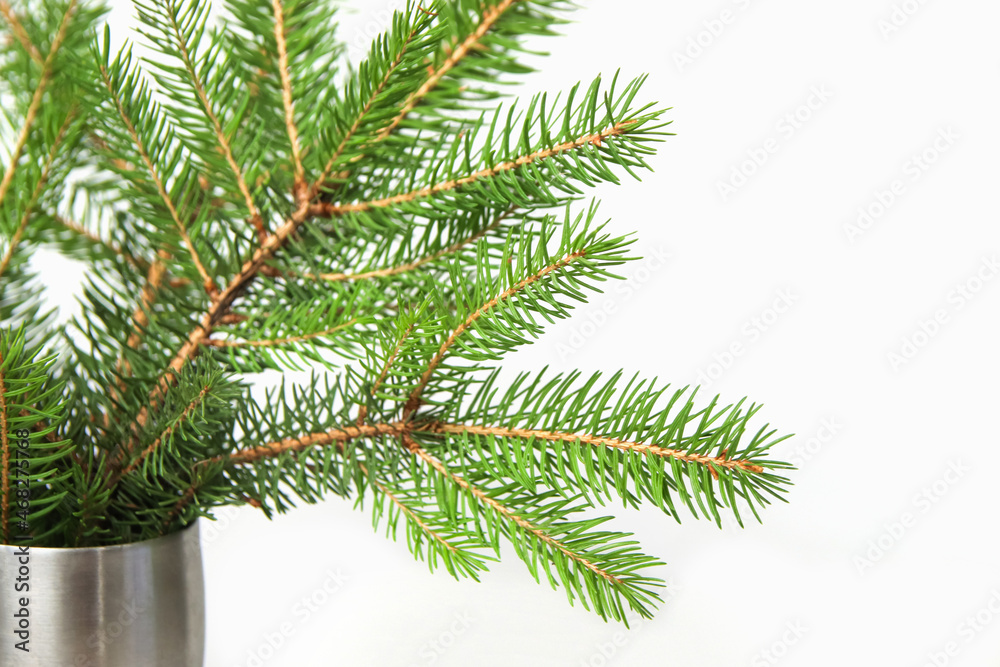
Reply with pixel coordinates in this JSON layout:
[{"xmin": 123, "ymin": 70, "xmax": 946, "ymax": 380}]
[{"xmin": 66, "ymin": 0, "xmax": 1000, "ymax": 667}]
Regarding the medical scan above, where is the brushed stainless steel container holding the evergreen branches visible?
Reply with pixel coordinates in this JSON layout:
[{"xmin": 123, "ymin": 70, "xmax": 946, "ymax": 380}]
[{"xmin": 0, "ymin": 521, "xmax": 205, "ymax": 667}]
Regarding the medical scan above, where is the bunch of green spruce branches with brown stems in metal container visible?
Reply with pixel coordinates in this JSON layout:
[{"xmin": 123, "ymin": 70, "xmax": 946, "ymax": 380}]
[{"xmin": 0, "ymin": 0, "xmax": 790, "ymax": 620}]
